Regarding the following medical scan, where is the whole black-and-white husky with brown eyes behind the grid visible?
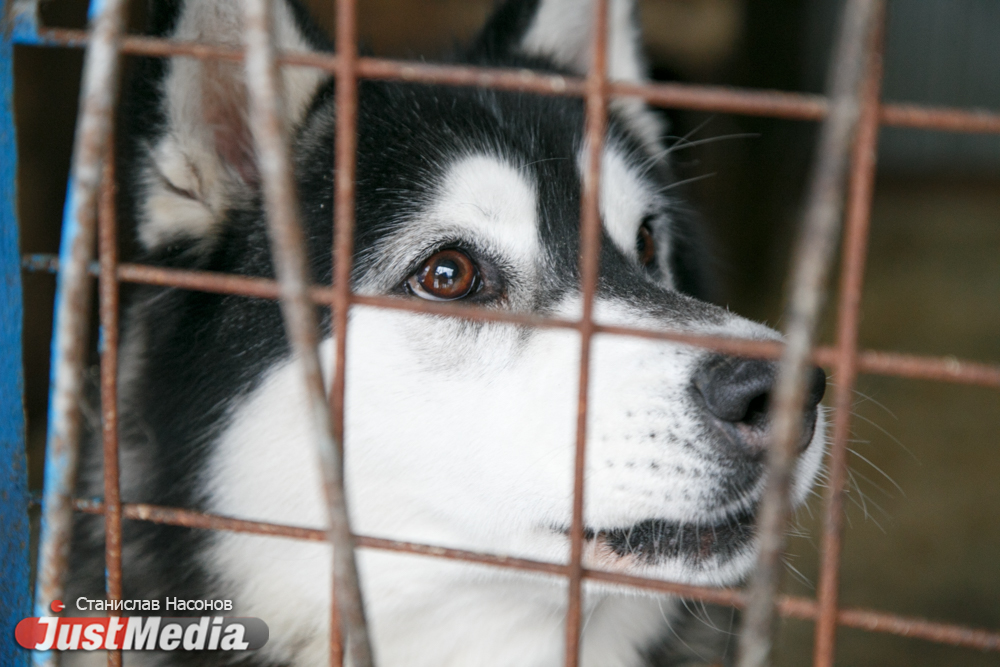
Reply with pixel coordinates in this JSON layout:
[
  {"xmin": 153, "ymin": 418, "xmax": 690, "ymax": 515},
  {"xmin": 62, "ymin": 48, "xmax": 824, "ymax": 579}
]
[{"xmin": 72, "ymin": 0, "xmax": 825, "ymax": 667}]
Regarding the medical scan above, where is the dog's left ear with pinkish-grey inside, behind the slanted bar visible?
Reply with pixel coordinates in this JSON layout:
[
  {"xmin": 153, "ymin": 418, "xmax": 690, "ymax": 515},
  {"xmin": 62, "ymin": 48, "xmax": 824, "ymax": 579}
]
[{"xmin": 132, "ymin": 0, "xmax": 329, "ymax": 251}]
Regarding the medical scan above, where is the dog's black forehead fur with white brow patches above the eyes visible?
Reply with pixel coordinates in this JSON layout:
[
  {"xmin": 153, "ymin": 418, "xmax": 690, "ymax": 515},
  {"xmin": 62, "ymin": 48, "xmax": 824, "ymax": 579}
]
[{"xmin": 318, "ymin": 82, "xmax": 688, "ymax": 294}]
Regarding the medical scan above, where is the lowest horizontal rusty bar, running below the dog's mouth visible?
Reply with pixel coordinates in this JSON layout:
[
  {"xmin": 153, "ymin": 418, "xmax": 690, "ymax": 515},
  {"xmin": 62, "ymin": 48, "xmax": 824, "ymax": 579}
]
[{"xmin": 74, "ymin": 499, "xmax": 1000, "ymax": 652}]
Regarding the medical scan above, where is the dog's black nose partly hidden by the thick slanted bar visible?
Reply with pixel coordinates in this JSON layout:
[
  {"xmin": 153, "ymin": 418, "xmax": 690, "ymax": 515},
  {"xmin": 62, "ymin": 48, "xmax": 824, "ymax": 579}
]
[{"xmin": 694, "ymin": 356, "xmax": 826, "ymax": 452}]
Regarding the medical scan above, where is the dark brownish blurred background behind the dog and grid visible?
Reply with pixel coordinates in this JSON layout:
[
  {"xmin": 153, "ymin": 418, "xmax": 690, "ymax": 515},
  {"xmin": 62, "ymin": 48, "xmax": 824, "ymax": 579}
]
[{"xmin": 15, "ymin": 0, "xmax": 1000, "ymax": 667}]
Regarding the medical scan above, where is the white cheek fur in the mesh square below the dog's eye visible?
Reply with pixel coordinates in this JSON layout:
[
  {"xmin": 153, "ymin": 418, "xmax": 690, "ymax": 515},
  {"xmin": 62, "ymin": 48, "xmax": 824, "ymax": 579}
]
[{"xmin": 345, "ymin": 310, "xmax": 579, "ymax": 547}]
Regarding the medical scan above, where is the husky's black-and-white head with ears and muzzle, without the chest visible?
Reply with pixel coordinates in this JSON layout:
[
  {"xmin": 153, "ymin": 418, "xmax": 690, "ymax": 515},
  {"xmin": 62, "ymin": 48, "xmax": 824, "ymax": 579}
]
[{"xmin": 123, "ymin": 0, "xmax": 824, "ymax": 632}]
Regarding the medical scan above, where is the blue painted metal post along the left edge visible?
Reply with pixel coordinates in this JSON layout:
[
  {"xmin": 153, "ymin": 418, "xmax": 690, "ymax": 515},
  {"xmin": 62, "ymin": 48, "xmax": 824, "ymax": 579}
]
[{"xmin": 0, "ymin": 19, "xmax": 31, "ymax": 667}]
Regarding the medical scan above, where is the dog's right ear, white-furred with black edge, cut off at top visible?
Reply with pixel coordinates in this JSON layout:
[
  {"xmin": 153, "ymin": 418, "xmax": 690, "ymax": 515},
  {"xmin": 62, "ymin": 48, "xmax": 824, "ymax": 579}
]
[{"xmin": 472, "ymin": 0, "xmax": 664, "ymax": 153}]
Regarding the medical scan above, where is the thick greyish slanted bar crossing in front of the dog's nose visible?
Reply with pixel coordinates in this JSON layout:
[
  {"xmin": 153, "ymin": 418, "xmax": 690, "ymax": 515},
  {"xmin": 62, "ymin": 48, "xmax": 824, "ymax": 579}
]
[{"xmin": 737, "ymin": 5, "xmax": 883, "ymax": 667}]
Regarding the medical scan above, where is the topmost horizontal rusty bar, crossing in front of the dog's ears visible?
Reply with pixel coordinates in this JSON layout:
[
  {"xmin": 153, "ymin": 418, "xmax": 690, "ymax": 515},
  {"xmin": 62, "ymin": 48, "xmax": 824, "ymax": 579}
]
[{"xmin": 17, "ymin": 28, "xmax": 1000, "ymax": 134}]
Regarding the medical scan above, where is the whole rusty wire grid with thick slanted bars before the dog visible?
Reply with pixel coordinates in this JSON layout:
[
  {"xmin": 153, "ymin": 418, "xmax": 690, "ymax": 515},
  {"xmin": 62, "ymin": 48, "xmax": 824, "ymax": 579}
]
[{"xmin": 13, "ymin": 0, "xmax": 1000, "ymax": 667}]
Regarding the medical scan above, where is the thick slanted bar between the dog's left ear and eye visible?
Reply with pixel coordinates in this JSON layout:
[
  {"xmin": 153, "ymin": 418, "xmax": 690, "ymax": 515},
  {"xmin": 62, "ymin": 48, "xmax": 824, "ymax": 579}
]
[{"xmin": 244, "ymin": 0, "xmax": 373, "ymax": 667}]
